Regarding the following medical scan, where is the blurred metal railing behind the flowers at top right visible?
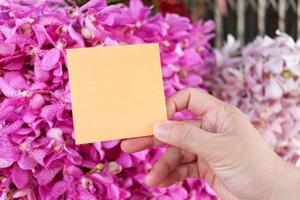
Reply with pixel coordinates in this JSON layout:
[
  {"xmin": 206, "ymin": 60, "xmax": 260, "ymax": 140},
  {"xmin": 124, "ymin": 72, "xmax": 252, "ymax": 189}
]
[{"xmin": 181, "ymin": 0, "xmax": 300, "ymax": 47}]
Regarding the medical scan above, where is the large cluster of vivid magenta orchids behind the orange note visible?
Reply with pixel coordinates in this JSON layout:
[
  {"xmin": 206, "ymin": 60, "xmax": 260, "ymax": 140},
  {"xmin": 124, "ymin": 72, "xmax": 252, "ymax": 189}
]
[{"xmin": 0, "ymin": 0, "xmax": 216, "ymax": 200}]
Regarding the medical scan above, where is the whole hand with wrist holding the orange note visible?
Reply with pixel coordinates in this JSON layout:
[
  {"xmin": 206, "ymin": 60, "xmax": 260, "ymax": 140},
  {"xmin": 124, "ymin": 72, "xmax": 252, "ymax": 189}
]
[{"xmin": 121, "ymin": 88, "xmax": 300, "ymax": 200}]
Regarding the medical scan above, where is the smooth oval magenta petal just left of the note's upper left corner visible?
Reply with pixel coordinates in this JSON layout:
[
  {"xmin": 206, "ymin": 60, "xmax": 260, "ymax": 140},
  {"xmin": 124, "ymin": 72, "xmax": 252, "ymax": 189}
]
[{"xmin": 40, "ymin": 48, "xmax": 60, "ymax": 71}]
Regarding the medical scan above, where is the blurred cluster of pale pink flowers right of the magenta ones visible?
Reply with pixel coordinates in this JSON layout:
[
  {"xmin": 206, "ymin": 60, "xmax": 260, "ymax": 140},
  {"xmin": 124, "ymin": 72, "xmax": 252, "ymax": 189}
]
[{"xmin": 211, "ymin": 33, "xmax": 300, "ymax": 166}]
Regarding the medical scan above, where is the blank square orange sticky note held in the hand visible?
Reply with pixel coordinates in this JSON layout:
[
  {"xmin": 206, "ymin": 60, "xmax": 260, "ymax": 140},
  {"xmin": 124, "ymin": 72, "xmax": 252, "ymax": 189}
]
[{"xmin": 67, "ymin": 44, "xmax": 167, "ymax": 144}]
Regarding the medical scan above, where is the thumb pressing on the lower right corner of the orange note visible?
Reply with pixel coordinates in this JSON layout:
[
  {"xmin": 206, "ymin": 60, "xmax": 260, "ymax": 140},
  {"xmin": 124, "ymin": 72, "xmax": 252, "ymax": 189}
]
[{"xmin": 153, "ymin": 121, "xmax": 217, "ymax": 156}]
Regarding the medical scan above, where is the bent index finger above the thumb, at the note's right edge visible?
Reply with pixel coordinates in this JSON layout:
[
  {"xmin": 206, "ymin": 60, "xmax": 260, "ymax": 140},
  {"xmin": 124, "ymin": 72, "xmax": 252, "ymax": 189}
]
[{"xmin": 166, "ymin": 87, "xmax": 222, "ymax": 119}]
